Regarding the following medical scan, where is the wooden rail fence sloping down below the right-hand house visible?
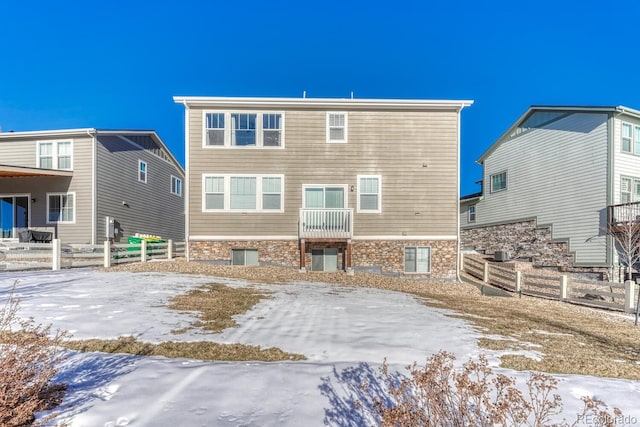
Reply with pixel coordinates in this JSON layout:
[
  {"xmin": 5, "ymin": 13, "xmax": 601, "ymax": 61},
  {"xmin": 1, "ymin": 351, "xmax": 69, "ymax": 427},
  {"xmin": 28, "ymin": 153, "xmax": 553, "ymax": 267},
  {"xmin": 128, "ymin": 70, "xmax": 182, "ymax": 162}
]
[{"xmin": 462, "ymin": 254, "xmax": 638, "ymax": 313}]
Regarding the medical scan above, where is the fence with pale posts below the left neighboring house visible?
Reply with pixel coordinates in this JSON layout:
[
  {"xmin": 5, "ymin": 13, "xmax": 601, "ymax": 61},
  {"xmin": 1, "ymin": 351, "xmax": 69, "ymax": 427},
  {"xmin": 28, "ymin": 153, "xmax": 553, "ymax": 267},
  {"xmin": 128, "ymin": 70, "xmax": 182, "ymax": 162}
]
[{"xmin": 0, "ymin": 239, "xmax": 185, "ymax": 272}]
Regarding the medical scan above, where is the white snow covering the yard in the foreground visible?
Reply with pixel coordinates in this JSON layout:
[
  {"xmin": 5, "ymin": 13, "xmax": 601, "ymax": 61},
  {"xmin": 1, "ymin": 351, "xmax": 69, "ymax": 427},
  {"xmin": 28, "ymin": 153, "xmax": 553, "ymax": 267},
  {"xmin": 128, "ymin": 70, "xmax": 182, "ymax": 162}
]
[{"xmin": 0, "ymin": 269, "xmax": 640, "ymax": 427}]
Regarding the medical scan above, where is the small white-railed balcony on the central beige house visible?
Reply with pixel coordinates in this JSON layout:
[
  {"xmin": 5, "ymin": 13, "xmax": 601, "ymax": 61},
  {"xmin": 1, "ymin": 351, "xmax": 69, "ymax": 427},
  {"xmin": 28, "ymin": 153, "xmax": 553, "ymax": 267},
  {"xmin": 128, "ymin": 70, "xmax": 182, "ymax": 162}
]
[{"xmin": 298, "ymin": 209, "xmax": 353, "ymax": 239}]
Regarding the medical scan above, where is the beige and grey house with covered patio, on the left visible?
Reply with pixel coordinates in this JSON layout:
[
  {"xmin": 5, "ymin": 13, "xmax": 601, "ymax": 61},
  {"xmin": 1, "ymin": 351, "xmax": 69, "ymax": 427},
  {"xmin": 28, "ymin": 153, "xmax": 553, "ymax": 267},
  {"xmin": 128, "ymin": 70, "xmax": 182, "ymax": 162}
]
[{"xmin": 0, "ymin": 129, "xmax": 184, "ymax": 244}]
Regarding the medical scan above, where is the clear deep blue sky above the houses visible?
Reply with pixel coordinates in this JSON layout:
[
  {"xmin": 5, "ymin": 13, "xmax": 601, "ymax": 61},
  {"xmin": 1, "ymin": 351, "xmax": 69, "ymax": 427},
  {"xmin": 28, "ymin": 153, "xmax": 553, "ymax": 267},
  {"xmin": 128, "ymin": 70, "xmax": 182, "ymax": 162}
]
[{"xmin": 0, "ymin": 0, "xmax": 640, "ymax": 194}]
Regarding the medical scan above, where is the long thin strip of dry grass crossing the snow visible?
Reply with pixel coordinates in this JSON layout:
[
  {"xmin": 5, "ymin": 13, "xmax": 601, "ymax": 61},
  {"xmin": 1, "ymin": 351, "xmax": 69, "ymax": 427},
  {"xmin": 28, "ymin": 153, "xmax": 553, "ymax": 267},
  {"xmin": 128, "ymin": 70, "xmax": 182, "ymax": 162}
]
[{"xmin": 65, "ymin": 337, "xmax": 305, "ymax": 362}]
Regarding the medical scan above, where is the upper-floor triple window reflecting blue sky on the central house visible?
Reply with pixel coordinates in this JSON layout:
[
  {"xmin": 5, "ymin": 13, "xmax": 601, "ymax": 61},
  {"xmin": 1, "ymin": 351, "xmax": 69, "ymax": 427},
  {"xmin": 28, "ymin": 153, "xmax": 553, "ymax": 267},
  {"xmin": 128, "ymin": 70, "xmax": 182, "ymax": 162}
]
[{"xmin": 202, "ymin": 111, "xmax": 284, "ymax": 148}]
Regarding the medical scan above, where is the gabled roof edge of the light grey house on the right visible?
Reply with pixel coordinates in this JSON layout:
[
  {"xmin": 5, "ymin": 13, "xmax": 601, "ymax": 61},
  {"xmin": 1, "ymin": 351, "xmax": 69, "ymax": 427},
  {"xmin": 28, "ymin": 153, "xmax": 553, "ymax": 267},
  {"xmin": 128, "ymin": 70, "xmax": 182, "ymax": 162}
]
[{"xmin": 476, "ymin": 105, "xmax": 640, "ymax": 164}]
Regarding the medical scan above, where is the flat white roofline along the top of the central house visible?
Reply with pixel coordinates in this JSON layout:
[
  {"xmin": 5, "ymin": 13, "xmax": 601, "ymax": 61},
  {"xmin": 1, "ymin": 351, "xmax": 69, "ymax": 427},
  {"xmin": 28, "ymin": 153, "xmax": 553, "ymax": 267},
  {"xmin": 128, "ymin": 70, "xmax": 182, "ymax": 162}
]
[{"xmin": 173, "ymin": 96, "xmax": 473, "ymax": 110}]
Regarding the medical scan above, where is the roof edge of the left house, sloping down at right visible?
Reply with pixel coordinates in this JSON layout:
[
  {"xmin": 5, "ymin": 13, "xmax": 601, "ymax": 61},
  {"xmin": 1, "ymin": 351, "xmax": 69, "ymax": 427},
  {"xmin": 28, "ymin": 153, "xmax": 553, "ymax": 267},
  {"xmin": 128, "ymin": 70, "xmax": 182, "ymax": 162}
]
[{"xmin": 0, "ymin": 128, "xmax": 184, "ymax": 174}]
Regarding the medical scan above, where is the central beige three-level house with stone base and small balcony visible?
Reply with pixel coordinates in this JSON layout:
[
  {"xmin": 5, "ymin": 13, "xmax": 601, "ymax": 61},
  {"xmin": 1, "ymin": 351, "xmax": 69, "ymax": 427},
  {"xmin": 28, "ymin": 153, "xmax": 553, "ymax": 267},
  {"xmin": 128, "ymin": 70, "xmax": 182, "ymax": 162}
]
[{"xmin": 174, "ymin": 97, "xmax": 472, "ymax": 278}]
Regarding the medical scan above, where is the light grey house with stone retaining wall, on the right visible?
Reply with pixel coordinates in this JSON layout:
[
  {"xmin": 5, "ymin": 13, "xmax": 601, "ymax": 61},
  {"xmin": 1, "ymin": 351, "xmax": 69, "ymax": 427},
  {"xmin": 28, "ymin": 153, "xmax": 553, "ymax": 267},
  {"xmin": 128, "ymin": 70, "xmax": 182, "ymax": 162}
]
[{"xmin": 460, "ymin": 106, "xmax": 640, "ymax": 277}]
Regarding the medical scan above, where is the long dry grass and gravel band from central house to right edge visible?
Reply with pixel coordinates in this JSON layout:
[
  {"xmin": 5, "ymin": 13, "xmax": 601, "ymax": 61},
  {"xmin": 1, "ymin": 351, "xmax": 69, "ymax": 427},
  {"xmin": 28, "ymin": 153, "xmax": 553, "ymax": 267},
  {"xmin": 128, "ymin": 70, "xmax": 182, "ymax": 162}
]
[{"xmin": 111, "ymin": 260, "xmax": 640, "ymax": 380}]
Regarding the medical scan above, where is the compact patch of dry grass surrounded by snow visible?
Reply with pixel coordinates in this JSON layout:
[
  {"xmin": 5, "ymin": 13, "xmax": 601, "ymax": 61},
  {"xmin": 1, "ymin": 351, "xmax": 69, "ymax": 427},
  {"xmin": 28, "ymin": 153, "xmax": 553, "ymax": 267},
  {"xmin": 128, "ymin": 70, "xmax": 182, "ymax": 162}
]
[{"xmin": 169, "ymin": 283, "xmax": 269, "ymax": 332}]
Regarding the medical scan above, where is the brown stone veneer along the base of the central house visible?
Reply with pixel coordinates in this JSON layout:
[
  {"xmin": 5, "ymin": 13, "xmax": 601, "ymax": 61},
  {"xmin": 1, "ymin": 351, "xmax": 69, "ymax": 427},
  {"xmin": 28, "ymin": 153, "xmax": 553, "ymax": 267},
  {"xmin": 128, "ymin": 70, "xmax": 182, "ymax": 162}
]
[{"xmin": 187, "ymin": 240, "xmax": 457, "ymax": 279}]
